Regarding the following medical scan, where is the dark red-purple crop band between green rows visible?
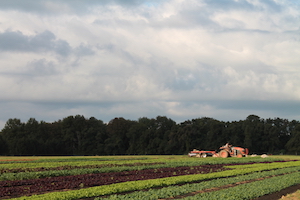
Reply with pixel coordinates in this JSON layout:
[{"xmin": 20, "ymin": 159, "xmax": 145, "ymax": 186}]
[{"xmin": 0, "ymin": 164, "xmax": 228, "ymax": 198}]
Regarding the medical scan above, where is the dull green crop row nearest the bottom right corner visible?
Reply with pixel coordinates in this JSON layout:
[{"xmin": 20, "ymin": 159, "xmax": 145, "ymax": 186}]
[{"xmin": 184, "ymin": 172, "xmax": 300, "ymax": 200}]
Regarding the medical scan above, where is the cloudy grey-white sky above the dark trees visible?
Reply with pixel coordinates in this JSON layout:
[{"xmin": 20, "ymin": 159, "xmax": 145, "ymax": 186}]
[{"xmin": 0, "ymin": 0, "xmax": 300, "ymax": 130}]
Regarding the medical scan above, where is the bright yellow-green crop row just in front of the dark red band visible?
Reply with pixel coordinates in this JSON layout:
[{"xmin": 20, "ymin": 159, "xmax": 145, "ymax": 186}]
[{"xmin": 8, "ymin": 161, "xmax": 300, "ymax": 200}]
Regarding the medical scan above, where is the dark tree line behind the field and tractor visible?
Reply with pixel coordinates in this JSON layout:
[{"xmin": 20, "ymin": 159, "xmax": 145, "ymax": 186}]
[{"xmin": 0, "ymin": 115, "xmax": 300, "ymax": 155}]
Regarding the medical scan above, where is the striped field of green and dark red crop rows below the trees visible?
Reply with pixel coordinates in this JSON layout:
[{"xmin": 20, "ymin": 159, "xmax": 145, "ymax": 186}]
[{"xmin": 0, "ymin": 155, "xmax": 300, "ymax": 200}]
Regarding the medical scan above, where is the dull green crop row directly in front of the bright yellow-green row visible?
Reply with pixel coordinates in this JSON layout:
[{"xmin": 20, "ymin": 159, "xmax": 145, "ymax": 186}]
[{"xmin": 95, "ymin": 166, "xmax": 300, "ymax": 200}]
